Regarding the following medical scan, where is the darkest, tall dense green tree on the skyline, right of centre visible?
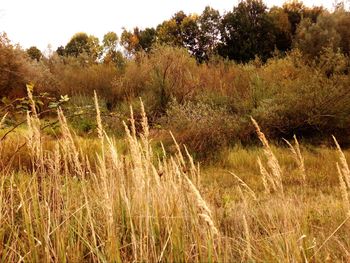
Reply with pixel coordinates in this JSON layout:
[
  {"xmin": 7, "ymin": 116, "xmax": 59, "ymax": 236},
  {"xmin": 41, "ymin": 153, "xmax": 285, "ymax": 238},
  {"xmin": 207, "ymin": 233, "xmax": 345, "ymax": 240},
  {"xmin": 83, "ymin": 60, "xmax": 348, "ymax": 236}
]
[{"xmin": 218, "ymin": 0, "xmax": 275, "ymax": 62}]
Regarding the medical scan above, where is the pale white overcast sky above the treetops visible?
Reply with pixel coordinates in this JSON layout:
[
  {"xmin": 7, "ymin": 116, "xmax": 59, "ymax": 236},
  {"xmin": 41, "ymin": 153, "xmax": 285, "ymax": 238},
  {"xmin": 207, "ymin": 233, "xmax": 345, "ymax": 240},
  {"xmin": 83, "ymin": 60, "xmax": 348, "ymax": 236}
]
[{"xmin": 0, "ymin": 0, "xmax": 333, "ymax": 51}]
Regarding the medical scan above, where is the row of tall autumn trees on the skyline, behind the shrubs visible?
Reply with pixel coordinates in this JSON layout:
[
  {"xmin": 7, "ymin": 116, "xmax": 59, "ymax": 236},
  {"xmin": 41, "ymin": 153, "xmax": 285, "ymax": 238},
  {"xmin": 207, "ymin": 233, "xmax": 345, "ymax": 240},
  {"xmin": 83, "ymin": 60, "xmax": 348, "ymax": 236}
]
[{"xmin": 50, "ymin": 0, "xmax": 350, "ymax": 62}]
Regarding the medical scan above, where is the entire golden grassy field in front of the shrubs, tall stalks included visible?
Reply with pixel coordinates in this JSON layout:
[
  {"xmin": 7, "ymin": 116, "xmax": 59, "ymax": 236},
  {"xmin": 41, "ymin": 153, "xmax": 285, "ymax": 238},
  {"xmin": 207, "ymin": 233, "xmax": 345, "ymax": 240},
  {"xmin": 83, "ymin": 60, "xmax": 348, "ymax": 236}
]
[{"xmin": 0, "ymin": 94, "xmax": 350, "ymax": 262}]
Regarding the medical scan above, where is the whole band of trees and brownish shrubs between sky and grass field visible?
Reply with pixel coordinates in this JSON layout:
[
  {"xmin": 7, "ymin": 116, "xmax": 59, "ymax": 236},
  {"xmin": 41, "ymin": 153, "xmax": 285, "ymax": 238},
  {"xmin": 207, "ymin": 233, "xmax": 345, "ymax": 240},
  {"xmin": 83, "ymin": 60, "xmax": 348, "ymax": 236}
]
[{"xmin": 0, "ymin": 0, "xmax": 350, "ymax": 155}]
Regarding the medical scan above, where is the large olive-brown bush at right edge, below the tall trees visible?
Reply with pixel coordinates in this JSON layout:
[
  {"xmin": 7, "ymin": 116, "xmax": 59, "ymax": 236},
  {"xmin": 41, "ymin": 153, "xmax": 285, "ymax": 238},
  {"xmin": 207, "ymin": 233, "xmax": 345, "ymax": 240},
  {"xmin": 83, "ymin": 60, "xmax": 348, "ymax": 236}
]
[{"xmin": 252, "ymin": 50, "xmax": 350, "ymax": 142}]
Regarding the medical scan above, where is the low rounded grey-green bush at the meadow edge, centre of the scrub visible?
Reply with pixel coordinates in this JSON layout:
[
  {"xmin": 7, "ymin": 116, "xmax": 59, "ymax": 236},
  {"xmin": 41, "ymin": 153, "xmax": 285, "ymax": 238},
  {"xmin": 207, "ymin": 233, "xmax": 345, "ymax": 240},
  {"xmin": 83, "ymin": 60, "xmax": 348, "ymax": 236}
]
[{"xmin": 162, "ymin": 101, "xmax": 245, "ymax": 158}]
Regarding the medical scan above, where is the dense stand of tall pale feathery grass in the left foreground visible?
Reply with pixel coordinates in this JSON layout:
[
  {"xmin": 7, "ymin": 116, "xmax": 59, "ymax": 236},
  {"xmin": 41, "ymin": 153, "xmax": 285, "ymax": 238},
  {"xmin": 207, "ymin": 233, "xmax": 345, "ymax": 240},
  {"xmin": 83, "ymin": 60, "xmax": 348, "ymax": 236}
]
[{"xmin": 0, "ymin": 95, "xmax": 222, "ymax": 262}]
